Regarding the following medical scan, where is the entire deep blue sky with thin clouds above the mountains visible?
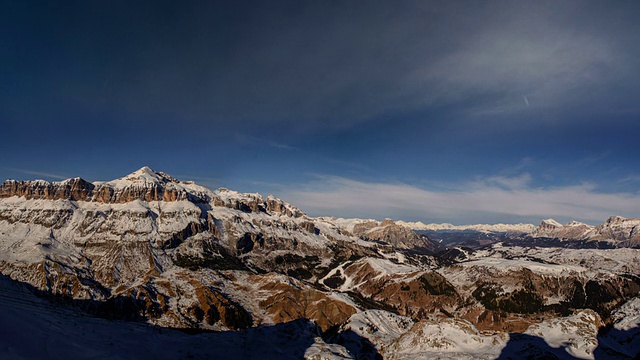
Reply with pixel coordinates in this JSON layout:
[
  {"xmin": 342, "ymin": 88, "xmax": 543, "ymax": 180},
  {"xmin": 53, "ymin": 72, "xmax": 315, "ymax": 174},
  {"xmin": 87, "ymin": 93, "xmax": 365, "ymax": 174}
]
[{"xmin": 0, "ymin": 0, "xmax": 640, "ymax": 224}]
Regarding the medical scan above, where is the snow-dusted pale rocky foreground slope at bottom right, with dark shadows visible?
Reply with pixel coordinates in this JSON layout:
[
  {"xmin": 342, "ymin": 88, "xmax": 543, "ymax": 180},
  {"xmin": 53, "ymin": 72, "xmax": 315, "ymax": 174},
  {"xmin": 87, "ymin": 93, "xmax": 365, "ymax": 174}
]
[{"xmin": 339, "ymin": 301, "xmax": 640, "ymax": 359}]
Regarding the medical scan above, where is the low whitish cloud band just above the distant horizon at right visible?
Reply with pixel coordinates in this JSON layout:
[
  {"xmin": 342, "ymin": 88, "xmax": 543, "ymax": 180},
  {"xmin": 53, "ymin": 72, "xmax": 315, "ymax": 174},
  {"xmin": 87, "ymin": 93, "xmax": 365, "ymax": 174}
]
[{"xmin": 281, "ymin": 174, "xmax": 640, "ymax": 224}]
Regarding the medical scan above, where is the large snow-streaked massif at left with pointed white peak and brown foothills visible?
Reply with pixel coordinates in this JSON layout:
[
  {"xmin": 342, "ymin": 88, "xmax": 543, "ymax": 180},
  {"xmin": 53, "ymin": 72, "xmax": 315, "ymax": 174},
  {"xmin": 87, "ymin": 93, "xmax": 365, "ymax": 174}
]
[{"xmin": 0, "ymin": 167, "xmax": 442, "ymax": 329}]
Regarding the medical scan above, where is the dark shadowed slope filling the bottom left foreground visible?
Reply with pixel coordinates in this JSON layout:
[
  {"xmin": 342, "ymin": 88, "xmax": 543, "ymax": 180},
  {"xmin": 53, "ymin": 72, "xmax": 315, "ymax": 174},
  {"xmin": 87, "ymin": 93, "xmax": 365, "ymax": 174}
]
[{"xmin": 0, "ymin": 276, "xmax": 360, "ymax": 359}]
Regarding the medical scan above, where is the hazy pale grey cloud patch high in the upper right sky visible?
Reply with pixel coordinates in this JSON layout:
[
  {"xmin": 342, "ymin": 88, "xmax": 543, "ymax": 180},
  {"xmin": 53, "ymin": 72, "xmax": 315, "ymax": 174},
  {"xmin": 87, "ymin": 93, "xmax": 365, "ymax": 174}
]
[{"xmin": 405, "ymin": 5, "xmax": 637, "ymax": 120}]
